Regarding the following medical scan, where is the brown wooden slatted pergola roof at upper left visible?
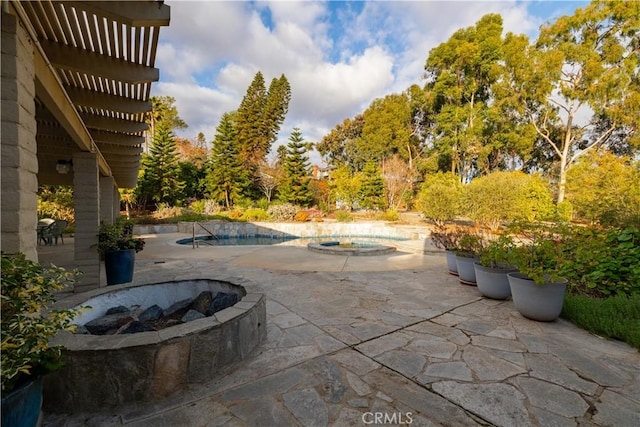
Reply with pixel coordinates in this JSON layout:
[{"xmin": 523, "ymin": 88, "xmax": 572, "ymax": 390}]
[{"xmin": 12, "ymin": 0, "xmax": 170, "ymax": 188}]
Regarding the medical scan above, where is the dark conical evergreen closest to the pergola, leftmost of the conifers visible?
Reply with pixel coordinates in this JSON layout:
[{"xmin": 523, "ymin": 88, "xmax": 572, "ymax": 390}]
[{"xmin": 136, "ymin": 121, "xmax": 185, "ymax": 205}]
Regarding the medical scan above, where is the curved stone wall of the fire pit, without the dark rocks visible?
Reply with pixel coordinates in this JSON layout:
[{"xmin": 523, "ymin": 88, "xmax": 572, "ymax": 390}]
[{"xmin": 44, "ymin": 279, "xmax": 266, "ymax": 413}]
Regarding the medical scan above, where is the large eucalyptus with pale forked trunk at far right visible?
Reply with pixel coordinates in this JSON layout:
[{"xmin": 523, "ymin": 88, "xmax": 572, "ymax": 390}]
[{"xmin": 505, "ymin": 1, "xmax": 640, "ymax": 202}]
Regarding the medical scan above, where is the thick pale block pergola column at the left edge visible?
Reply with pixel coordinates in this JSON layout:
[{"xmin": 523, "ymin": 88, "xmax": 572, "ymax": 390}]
[{"xmin": 0, "ymin": 12, "xmax": 38, "ymax": 261}]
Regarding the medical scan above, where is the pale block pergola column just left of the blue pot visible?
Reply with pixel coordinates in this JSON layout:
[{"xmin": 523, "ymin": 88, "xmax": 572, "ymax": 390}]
[{"xmin": 73, "ymin": 152, "xmax": 101, "ymax": 292}]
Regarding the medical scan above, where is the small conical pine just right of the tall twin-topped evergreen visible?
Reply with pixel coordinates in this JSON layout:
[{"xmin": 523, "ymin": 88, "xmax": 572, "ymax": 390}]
[{"xmin": 278, "ymin": 128, "xmax": 313, "ymax": 206}]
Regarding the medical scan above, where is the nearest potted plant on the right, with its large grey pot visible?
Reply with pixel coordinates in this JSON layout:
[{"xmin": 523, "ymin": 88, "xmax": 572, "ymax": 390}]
[{"xmin": 507, "ymin": 223, "xmax": 569, "ymax": 322}]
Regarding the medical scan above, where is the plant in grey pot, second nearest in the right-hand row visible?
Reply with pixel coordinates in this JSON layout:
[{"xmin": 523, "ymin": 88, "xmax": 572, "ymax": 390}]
[{"xmin": 473, "ymin": 233, "xmax": 517, "ymax": 299}]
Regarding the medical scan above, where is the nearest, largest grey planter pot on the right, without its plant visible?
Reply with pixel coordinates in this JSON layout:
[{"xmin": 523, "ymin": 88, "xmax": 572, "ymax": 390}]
[{"xmin": 507, "ymin": 273, "xmax": 567, "ymax": 322}]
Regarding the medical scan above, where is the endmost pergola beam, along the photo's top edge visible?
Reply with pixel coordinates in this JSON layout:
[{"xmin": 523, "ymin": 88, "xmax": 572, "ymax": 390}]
[{"xmin": 63, "ymin": 1, "xmax": 171, "ymax": 27}]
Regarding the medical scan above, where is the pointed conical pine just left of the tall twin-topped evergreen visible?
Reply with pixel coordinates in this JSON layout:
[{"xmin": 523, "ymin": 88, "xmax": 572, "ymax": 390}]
[{"xmin": 206, "ymin": 113, "xmax": 248, "ymax": 208}]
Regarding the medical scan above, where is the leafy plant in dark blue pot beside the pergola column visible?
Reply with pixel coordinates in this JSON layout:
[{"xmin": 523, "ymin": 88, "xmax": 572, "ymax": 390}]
[{"xmin": 98, "ymin": 220, "xmax": 145, "ymax": 285}]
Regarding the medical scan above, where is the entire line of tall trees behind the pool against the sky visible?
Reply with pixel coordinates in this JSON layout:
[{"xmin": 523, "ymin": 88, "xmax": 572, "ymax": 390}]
[{"xmin": 134, "ymin": 1, "xmax": 640, "ymax": 226}]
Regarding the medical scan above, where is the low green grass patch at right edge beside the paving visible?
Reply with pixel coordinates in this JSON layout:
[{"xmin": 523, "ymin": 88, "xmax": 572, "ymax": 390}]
[{"xmin": 561, "ymin": 294, "xmax": 640, "ymax": 350}]
